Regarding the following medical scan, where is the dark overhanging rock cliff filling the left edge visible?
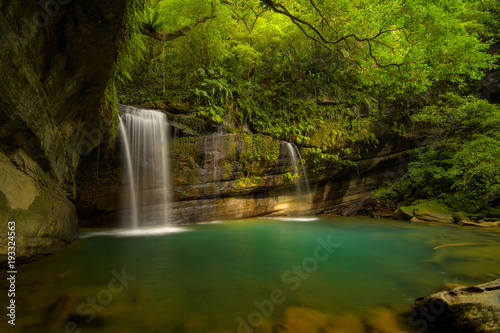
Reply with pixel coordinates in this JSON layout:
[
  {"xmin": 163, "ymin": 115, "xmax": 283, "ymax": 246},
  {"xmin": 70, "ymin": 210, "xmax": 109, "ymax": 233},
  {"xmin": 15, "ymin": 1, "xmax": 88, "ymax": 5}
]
[{"xmin": 0, "ymin": 0, "xmax": 127, "ymax": 263}]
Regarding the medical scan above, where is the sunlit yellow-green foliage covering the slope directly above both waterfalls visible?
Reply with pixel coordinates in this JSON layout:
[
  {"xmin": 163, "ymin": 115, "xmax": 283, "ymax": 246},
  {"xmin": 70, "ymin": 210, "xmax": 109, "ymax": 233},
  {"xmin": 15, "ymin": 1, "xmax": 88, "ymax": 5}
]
[{"xmin": 118, "ymin": 0, "xmax": 498, "ymax": 170}]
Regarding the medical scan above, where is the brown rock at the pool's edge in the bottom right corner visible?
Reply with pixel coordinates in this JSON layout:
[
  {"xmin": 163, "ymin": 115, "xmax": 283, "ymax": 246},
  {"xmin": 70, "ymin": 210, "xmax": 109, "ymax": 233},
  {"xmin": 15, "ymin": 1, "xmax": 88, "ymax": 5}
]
[{"xmin": 413, "ymin": 279, "xmax": 500, "ymax": 333}]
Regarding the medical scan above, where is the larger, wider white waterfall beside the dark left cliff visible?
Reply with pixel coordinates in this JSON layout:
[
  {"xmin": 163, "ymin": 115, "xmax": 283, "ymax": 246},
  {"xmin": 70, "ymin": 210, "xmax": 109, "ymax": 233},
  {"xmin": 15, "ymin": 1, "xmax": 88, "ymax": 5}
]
[{"xmin": 119, "ymin": 108, "xmax": 170, "ymax": 229}]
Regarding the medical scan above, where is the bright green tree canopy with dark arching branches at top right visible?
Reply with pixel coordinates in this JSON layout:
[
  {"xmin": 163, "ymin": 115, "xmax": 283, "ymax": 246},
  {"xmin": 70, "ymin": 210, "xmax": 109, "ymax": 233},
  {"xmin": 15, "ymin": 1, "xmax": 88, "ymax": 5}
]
[{"xmin": 260, "ymin": 0, "xmax": 494, "ymax": 92}]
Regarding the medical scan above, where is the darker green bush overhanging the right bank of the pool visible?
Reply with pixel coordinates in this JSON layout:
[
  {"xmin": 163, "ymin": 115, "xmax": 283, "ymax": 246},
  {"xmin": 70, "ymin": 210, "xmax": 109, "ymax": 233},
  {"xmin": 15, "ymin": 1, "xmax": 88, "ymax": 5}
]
[{"xmin": 378, "ymin": 94, "xmax": 500, "ymax": 212}]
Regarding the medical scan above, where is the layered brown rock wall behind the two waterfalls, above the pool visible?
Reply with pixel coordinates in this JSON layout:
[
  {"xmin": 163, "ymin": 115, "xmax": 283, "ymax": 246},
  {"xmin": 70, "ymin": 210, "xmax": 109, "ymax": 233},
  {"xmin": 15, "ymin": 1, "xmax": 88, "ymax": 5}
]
[{"xmin": 76, "ymin": 106, "xmax": 436, "ymax": 226}]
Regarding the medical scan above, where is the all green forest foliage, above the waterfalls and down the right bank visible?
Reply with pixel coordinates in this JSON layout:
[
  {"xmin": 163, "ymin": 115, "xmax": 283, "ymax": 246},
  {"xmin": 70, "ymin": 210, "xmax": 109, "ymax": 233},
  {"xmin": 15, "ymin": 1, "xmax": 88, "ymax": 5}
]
[{"xmin": 109, "ymin": 0, "xmax": 500, "ymax": 205}]
